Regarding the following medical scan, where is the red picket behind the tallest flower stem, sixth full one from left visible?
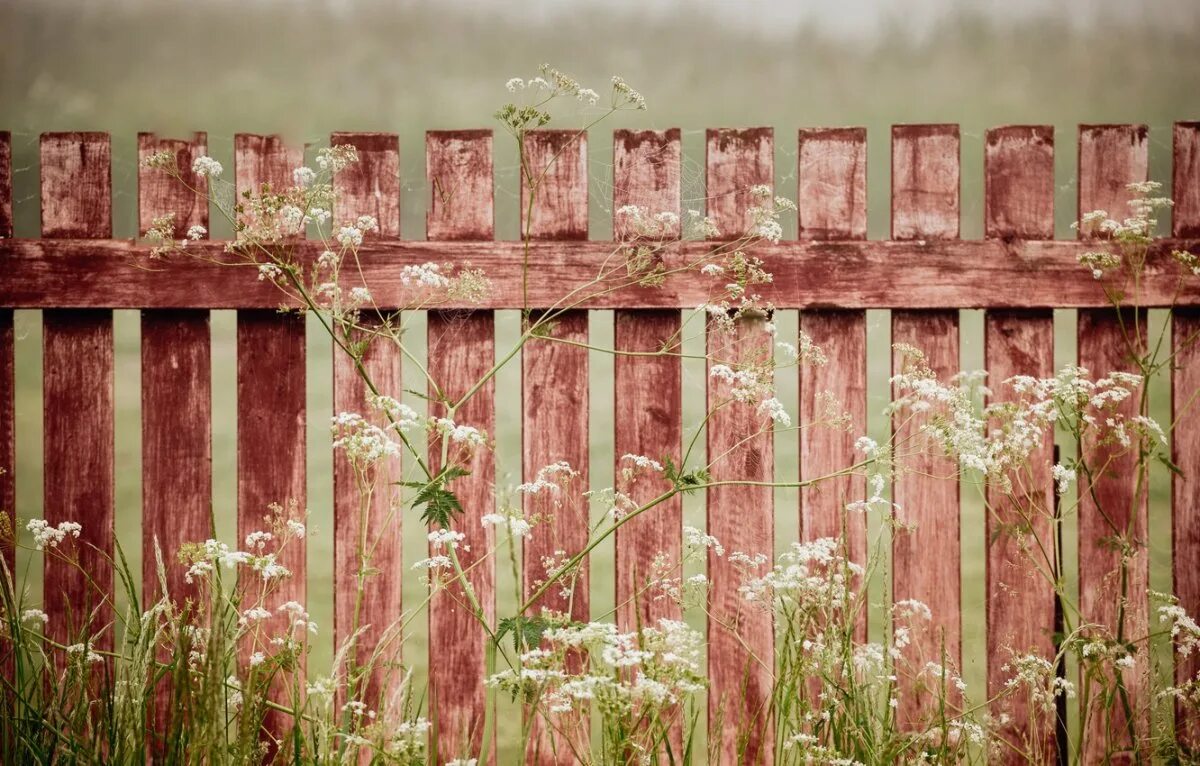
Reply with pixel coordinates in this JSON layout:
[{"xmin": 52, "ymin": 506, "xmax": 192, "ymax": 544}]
[{"xmin": 520, "ymin": 131, "xmax": 590, "ymax": 764}]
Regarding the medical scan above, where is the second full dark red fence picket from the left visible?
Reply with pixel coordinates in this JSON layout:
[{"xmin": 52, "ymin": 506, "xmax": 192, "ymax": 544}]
[{"xmin": 138, "ymin": 133, "xmax": 212, "ymax": 604}]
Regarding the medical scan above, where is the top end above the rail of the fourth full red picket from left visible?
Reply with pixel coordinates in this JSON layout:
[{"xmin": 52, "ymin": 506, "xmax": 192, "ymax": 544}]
[{"xmin": 329, "ymin": 133, "xmax": 400, "ymax": 238}]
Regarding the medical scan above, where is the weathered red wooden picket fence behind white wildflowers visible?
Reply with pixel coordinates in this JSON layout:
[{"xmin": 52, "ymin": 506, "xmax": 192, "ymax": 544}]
[{"xmin": 0, "ymin": 122, "xmax": 1200, "ymax": 760}]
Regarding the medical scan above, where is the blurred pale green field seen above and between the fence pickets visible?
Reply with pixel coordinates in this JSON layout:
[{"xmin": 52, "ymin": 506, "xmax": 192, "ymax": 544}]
[{"xmin": 0, "ymin": 0, "xmax": 1200, "ymax": 758}]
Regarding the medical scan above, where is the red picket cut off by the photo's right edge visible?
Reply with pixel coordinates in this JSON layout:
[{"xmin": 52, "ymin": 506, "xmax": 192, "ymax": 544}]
[{"xmin": 1171, "ymin": 122, "xmax": 1200, "ymax": 750}]
